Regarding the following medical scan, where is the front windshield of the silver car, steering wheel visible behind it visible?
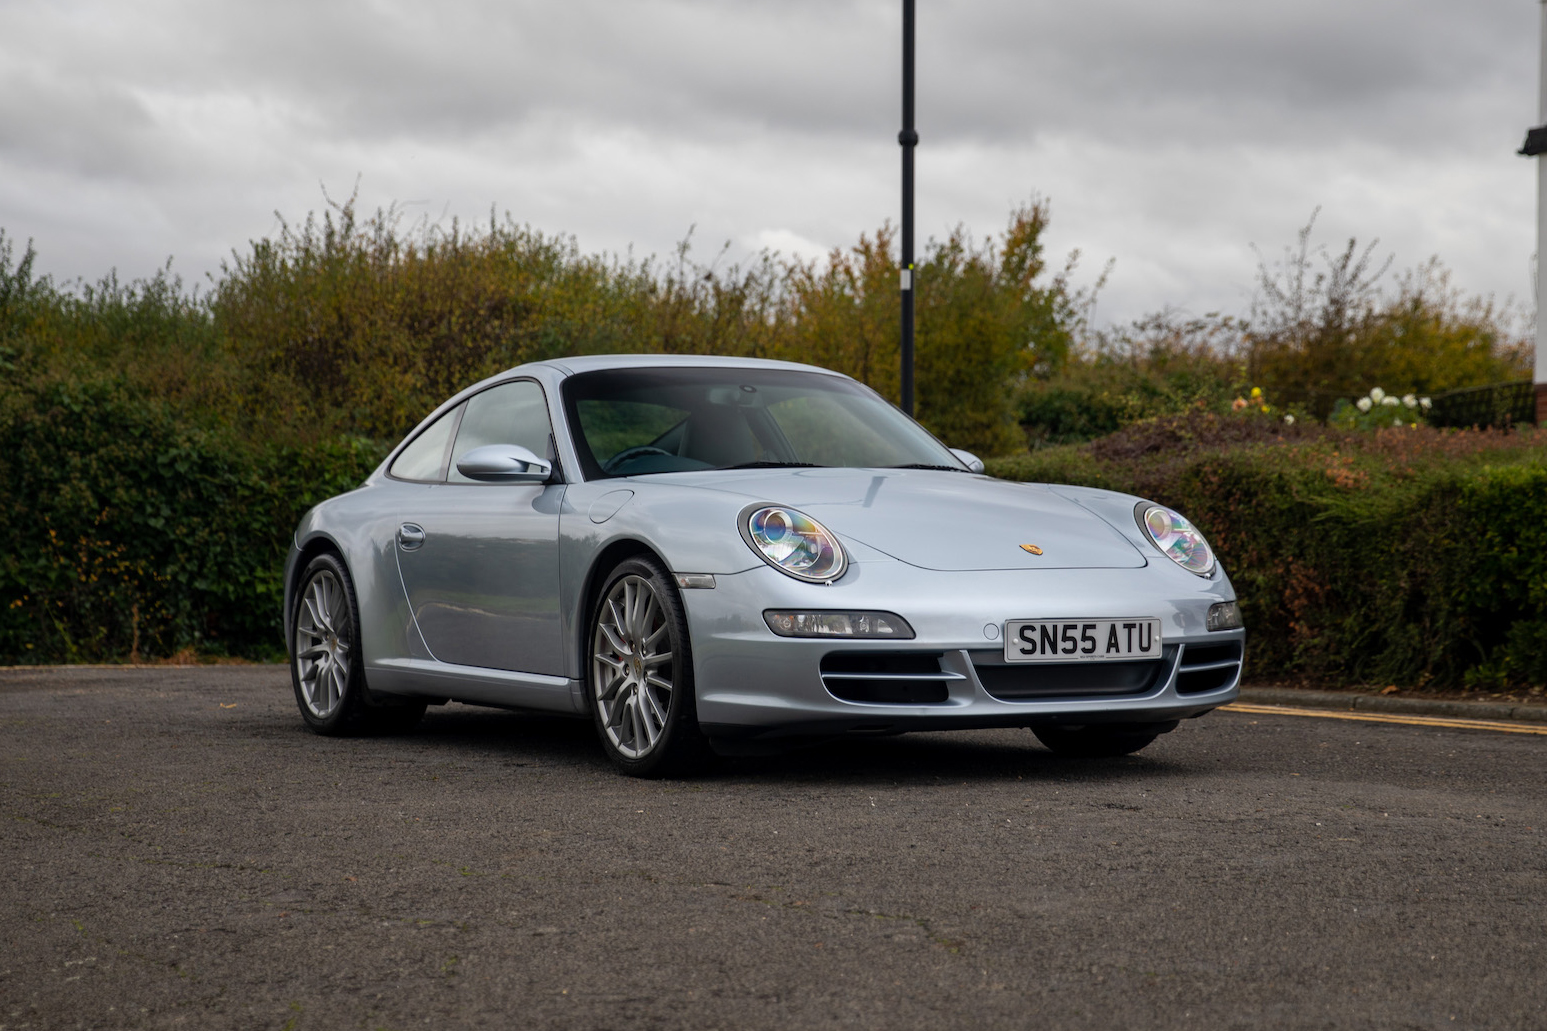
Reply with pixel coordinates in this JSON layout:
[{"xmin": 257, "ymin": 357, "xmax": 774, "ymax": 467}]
[{"xmin": 563, "ymin": 367, "xmax": 965, "ymax": 480}]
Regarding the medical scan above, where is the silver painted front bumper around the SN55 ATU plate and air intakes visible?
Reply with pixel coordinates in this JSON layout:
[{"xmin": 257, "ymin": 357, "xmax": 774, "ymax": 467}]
[{"xmin": 682, "ymin": 560, "xmax": 1244, "ymax": 745}]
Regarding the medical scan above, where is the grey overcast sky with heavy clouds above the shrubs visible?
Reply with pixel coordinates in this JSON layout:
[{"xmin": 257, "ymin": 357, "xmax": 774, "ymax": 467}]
[{"xmin": 0, "ymin": 0, "xmax": 1539, "ymax": 322}]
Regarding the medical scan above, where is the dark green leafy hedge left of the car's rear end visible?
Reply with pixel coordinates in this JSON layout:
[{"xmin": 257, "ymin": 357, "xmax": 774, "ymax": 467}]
[{"xmin": 0, "ymin": 381, "xmax": 384, "ymax": 663}]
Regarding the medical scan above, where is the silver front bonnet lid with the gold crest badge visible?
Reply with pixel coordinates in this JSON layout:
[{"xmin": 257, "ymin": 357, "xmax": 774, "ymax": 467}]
[{"xmin": 636, "ymin": 469, "xmax": 1146, "ymax": 570}]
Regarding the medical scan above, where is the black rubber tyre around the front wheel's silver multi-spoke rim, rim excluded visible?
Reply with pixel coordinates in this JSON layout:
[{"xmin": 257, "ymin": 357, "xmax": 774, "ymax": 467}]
[{"xmin": 585, "ymin": 556, "xmax": 707, "ymax": 777}]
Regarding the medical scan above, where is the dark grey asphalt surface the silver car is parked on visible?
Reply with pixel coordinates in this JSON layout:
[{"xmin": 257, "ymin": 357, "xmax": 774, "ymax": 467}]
[{"xmin": 0, "ymin": 667, "xmax": 1547, "ymax": 1031}]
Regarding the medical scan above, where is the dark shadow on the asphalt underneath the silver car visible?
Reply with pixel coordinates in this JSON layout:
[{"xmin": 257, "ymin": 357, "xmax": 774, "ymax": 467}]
[{"xmin": 393, "ymin": 704, "xmax": 1205, "ymax": 786}]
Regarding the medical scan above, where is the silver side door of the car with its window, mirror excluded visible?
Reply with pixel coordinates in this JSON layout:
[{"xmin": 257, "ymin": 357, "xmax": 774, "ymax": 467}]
[{"xmin": 396, "ymin": 379, "xmax": 565, "ymax": 676}]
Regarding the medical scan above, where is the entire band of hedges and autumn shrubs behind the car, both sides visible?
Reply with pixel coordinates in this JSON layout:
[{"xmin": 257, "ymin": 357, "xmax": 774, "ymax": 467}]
[{"xmin": 0, "ymin": 201, "xmax": 1547, "ymax": 686}]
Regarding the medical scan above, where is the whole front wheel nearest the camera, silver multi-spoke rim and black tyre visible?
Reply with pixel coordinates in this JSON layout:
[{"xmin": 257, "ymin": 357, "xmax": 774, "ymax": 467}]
[{"xmin": 586, "ymin": 556, "xmax": 712, "ymax": 777}]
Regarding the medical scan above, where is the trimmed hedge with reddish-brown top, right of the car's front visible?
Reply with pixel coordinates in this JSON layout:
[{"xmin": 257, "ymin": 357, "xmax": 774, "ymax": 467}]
[{"xmin": 989, "ymin": 416, "xmax": 1547, "ymax": 687}]
